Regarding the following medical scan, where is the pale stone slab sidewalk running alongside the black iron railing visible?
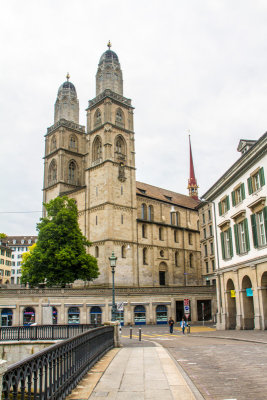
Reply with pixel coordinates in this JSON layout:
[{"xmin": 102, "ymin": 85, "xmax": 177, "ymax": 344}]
[{"xmin": 68, "ymin": 345, "xmax": 203, "ymax": 400}]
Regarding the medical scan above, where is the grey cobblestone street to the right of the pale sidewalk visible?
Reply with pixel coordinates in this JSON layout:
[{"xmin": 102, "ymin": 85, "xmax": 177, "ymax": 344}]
[{"xmin": 122, "ymin": 326, "xmax": 267, "ymax": 400}]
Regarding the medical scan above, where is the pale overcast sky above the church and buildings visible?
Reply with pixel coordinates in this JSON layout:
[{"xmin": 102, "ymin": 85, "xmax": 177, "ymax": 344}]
[{"xmin": 0, "ymin": 0, "xmax": 267, "ymax": 235}]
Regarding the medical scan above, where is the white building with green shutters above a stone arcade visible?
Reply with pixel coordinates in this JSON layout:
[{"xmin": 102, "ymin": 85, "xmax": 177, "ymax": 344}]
[{"xmin": 203, "ymin": 133, "xmax": 267, "ymax": 329}]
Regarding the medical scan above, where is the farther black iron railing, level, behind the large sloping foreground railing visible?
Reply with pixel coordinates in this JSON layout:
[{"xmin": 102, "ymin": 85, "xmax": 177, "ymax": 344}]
[{"xmin": 0, "ymin": 324, "xmax": 95, "ymax": 342}]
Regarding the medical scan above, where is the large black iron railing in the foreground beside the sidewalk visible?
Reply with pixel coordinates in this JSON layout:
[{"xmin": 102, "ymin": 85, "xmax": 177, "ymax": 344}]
[{"xmin": 2, "ymin": 326, "xmax": 114, "ymax": 400}]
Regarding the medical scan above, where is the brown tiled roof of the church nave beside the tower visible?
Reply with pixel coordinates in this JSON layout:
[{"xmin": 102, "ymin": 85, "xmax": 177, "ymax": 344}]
[{"xmin": 136, "ymin": 182, "xmax": 199, "ymax": 209}]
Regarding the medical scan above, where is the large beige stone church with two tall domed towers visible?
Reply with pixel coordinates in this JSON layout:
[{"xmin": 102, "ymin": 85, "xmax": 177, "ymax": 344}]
[{"xmin": 43, "ymin": 42, "xmax": 201, "ymax": 287}]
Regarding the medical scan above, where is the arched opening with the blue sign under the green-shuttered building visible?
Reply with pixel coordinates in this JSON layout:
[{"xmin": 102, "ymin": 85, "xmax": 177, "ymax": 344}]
[{"xmin": 242, "ymin": 275, "xmax": 254, "ymax": 329}]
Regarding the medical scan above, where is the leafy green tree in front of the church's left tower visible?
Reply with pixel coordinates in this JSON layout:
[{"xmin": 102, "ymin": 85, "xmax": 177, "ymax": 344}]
[{"xmin": 21, "ymin": 196, "xmax": 99, "ymax": 286}]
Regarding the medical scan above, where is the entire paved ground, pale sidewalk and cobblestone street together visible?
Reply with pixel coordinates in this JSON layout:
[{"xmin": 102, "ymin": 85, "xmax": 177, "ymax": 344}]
[{"xmin": 68, "ymin": 325, "xmax": 267, "ymax": 400}]
